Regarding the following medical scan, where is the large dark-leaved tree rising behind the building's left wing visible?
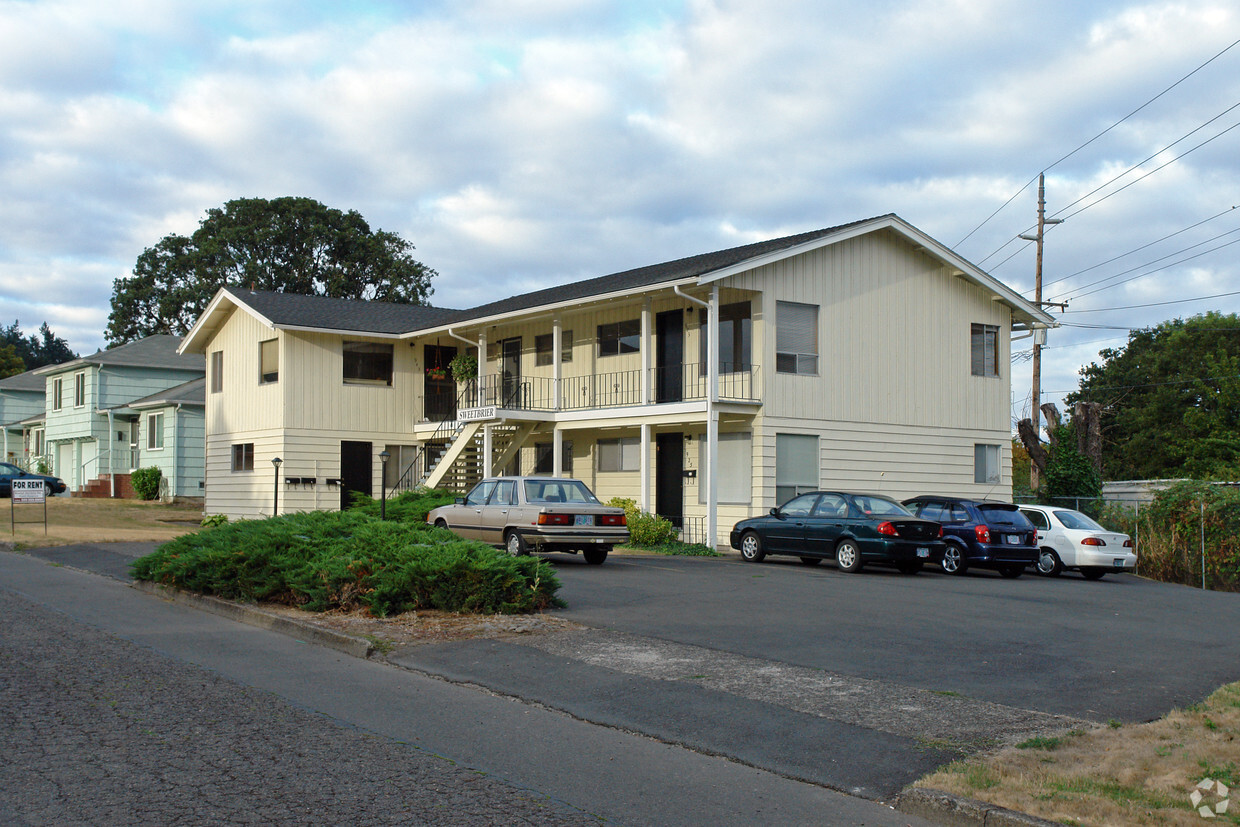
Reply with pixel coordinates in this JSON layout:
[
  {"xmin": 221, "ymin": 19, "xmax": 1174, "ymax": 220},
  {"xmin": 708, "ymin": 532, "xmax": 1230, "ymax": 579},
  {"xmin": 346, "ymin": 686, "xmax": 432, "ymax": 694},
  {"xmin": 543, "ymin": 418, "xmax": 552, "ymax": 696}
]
[{"xmin": 107, "ymin": 197, "xmax": 435, "ymax": 345}]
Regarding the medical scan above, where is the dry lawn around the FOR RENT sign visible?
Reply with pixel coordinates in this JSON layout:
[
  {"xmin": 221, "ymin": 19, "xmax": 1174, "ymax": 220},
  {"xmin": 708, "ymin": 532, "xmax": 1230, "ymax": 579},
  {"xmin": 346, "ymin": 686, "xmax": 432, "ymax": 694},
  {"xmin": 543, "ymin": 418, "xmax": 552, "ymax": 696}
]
[{"xmin": 0, "ymin": 497, "xmax": 202, "ymax": 548}]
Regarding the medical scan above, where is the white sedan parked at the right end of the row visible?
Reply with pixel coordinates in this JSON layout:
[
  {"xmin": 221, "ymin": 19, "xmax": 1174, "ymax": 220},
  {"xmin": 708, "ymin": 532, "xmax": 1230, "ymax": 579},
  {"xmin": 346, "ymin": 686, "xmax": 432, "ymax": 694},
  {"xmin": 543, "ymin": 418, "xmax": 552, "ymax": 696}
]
[{"xmin": 1021, "ymin": 506, "xmax": 1137, "ymax": 580}]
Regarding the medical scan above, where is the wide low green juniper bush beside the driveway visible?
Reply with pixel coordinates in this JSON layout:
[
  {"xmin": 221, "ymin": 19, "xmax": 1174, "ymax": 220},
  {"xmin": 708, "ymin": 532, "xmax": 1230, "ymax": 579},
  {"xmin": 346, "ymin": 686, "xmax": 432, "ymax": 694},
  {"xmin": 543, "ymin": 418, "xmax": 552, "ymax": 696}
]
[{"xmin": 133, "ymin": 506, "xmax": 563, "ymax": 616}]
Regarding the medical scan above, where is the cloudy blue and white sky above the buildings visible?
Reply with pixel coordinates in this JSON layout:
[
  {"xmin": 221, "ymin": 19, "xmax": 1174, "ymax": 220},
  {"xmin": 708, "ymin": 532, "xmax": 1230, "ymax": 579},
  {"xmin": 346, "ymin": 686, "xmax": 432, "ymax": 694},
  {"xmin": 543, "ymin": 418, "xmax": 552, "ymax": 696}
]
[{"xmin": 0, "ymin": 0, "xmax": 1240, "ymax": 426}]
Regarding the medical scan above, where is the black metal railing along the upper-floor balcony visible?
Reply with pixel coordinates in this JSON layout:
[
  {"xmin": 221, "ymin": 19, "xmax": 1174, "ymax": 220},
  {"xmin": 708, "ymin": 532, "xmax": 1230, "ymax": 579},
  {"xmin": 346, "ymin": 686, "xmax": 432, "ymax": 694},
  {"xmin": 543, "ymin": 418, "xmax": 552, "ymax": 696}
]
[{"xmin": 424, "ymin": 362, "xmax": 761, "ymax": 422}]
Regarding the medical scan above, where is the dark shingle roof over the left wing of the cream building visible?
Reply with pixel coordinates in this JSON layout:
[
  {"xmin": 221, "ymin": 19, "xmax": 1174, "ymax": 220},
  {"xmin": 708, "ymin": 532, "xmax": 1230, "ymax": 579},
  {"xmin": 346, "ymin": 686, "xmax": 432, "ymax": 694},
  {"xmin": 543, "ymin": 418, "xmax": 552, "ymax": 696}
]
[{"xmin": 230, "ymin": 288, "xmax": 460, "ymax": 332}]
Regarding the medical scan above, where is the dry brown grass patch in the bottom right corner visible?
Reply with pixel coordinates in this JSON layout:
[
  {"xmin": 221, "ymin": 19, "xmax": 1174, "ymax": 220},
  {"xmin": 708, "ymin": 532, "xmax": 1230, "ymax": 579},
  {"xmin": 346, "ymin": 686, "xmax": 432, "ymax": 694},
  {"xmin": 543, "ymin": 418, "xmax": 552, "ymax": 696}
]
[{"xmin": 915, "ymin": 683, "xmax": 1240, "ymax": 826}]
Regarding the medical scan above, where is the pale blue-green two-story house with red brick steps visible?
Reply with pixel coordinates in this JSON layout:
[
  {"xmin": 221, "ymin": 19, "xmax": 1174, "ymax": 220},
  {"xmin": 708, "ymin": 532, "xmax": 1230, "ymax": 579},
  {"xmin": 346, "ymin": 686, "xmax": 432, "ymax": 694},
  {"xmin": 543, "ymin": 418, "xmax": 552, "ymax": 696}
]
[{"xmin": 35, "ymin": 335, "xmax": 206, "ymax": 496}]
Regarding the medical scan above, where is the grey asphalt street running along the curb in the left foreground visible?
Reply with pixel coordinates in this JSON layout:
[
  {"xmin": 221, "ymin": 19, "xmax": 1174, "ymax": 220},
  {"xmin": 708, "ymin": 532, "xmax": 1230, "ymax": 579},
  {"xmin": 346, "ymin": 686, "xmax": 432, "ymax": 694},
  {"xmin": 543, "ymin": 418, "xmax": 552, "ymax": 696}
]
[{"xmin": 0, "ymin": 546, "xmax": 925, "ymax": 825}]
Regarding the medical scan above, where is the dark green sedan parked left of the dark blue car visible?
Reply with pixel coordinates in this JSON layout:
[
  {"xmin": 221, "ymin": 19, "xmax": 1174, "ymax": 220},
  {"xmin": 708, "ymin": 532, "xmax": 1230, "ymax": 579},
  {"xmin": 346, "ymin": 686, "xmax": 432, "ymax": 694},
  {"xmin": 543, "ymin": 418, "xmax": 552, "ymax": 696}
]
[{"xmin": 732, "ymin": 491, "xmax": 944, "ymax": 574}]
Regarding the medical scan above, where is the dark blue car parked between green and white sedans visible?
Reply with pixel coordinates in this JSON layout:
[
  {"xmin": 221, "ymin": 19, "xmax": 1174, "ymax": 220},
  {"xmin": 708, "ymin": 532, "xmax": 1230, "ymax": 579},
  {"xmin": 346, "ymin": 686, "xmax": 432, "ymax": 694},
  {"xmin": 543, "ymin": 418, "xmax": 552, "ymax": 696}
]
[{"xmin": 904, "ymin": 496, "xmax": 1038, "ymax": 578}]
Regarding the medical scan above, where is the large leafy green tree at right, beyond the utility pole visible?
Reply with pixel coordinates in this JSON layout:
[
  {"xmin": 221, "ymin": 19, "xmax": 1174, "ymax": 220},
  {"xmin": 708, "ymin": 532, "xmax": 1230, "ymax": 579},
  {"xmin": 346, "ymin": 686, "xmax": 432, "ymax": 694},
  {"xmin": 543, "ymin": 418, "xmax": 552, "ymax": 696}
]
[{"xmin": 1068, "ymin": 312, "xmax": 1240, "ymax": 480}]
